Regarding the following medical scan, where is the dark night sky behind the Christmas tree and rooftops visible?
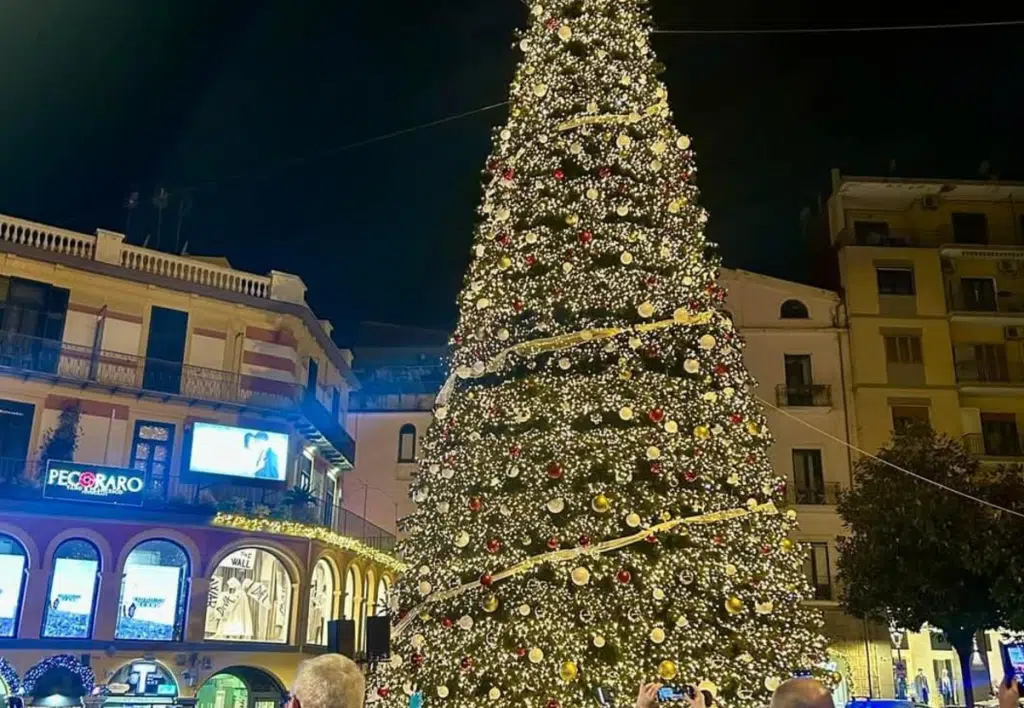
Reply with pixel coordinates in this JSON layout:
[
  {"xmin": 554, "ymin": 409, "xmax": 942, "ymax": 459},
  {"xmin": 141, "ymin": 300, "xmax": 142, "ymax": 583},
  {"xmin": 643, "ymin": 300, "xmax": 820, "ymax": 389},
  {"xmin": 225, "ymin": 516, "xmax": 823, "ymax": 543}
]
[{"xmin": 0, "ymin": 0, "xmax": 1024, "ymax": 343}]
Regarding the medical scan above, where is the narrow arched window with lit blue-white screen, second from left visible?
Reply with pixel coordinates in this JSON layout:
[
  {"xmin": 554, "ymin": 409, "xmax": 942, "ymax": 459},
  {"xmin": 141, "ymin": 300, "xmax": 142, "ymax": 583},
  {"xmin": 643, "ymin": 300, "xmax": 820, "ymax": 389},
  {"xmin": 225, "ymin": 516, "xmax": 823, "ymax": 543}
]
[{"xmin": 43, "ymin": 538, "xmax": 99, "ymax": 639}]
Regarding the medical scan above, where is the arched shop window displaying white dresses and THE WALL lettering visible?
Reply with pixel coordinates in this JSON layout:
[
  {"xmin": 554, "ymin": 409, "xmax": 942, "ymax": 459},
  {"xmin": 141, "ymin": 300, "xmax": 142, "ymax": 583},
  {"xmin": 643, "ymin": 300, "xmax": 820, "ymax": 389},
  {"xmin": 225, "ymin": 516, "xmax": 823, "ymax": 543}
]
[{"xmin": 206, "ymin": 548, "xmax": 292, "ymax": 644}]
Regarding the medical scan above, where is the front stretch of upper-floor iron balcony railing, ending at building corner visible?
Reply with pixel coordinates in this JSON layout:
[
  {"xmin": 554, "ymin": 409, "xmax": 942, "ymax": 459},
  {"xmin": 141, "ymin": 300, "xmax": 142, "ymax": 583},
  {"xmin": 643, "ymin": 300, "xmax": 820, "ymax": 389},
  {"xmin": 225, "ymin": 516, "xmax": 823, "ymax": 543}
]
[{"xmin": 0, "ymin": 332, "xmax": 303, "ymax": 409}]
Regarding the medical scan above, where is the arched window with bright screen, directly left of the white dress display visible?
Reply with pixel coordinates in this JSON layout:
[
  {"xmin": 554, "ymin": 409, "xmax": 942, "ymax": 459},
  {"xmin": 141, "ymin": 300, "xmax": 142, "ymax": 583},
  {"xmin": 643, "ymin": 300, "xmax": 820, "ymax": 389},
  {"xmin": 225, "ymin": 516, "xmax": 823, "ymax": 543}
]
[{"xmin": 114, "ymin": 539, "xmax": 190, "ymax": 641}]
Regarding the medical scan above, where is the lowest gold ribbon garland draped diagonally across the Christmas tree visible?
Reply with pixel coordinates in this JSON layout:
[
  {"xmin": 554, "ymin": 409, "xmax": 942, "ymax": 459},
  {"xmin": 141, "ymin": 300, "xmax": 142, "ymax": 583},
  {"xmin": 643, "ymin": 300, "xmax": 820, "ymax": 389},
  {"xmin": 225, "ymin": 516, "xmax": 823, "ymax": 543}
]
[{"xmin": 391, "ymin": 502, "xmax": 778, "ymax": 636}]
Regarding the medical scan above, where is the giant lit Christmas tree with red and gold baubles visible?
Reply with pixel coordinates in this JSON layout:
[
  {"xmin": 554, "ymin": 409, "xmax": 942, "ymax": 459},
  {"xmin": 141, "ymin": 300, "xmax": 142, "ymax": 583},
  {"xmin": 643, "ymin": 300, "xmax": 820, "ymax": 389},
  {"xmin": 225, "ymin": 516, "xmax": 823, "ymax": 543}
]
[{"xmin": 373, "ymin": 0, "xmax": 823, "ymax": 708}]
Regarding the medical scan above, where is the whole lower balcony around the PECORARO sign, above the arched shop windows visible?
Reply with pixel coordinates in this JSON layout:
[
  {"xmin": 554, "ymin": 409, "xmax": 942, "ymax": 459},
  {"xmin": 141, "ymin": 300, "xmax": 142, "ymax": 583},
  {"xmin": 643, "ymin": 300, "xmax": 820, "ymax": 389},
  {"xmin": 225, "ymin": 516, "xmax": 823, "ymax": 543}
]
[{"xmin": 0, "ymin": 458, "xmax": 395, "ymax": 551}]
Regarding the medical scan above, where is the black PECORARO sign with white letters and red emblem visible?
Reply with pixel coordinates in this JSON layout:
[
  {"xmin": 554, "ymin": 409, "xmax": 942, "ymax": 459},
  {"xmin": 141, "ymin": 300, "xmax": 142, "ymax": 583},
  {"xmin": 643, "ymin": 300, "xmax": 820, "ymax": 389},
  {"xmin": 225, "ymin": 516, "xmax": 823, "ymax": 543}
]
[{"xmin": 43, "ymin": 460, "xmax": 145, "ymax": 506}]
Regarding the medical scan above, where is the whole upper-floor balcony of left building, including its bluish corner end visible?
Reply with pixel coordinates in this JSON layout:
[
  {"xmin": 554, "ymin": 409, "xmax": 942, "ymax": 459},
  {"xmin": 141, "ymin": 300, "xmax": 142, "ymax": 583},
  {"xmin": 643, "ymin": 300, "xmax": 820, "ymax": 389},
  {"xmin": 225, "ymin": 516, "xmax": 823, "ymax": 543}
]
[{"xmin": 0, "ymin": 332, "xmax": 355, "ymax": 468}]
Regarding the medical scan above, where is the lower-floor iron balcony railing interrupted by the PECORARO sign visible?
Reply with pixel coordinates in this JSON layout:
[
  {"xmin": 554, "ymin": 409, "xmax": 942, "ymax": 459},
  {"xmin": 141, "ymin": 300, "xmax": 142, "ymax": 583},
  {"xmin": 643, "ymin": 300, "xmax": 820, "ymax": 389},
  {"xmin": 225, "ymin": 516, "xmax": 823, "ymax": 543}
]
[{"xmin": 0, "ymin": 458, "xmax": 395, "ymax": 550}]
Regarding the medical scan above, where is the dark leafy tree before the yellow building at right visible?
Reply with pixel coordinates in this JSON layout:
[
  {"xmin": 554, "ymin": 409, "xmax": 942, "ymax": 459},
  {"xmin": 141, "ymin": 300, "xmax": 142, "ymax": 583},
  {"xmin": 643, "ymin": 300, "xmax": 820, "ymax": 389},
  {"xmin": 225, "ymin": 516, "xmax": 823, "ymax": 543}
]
[{"xmin": 839, "ymin": 426, "xmax": 1024, "ymax": 708}]
